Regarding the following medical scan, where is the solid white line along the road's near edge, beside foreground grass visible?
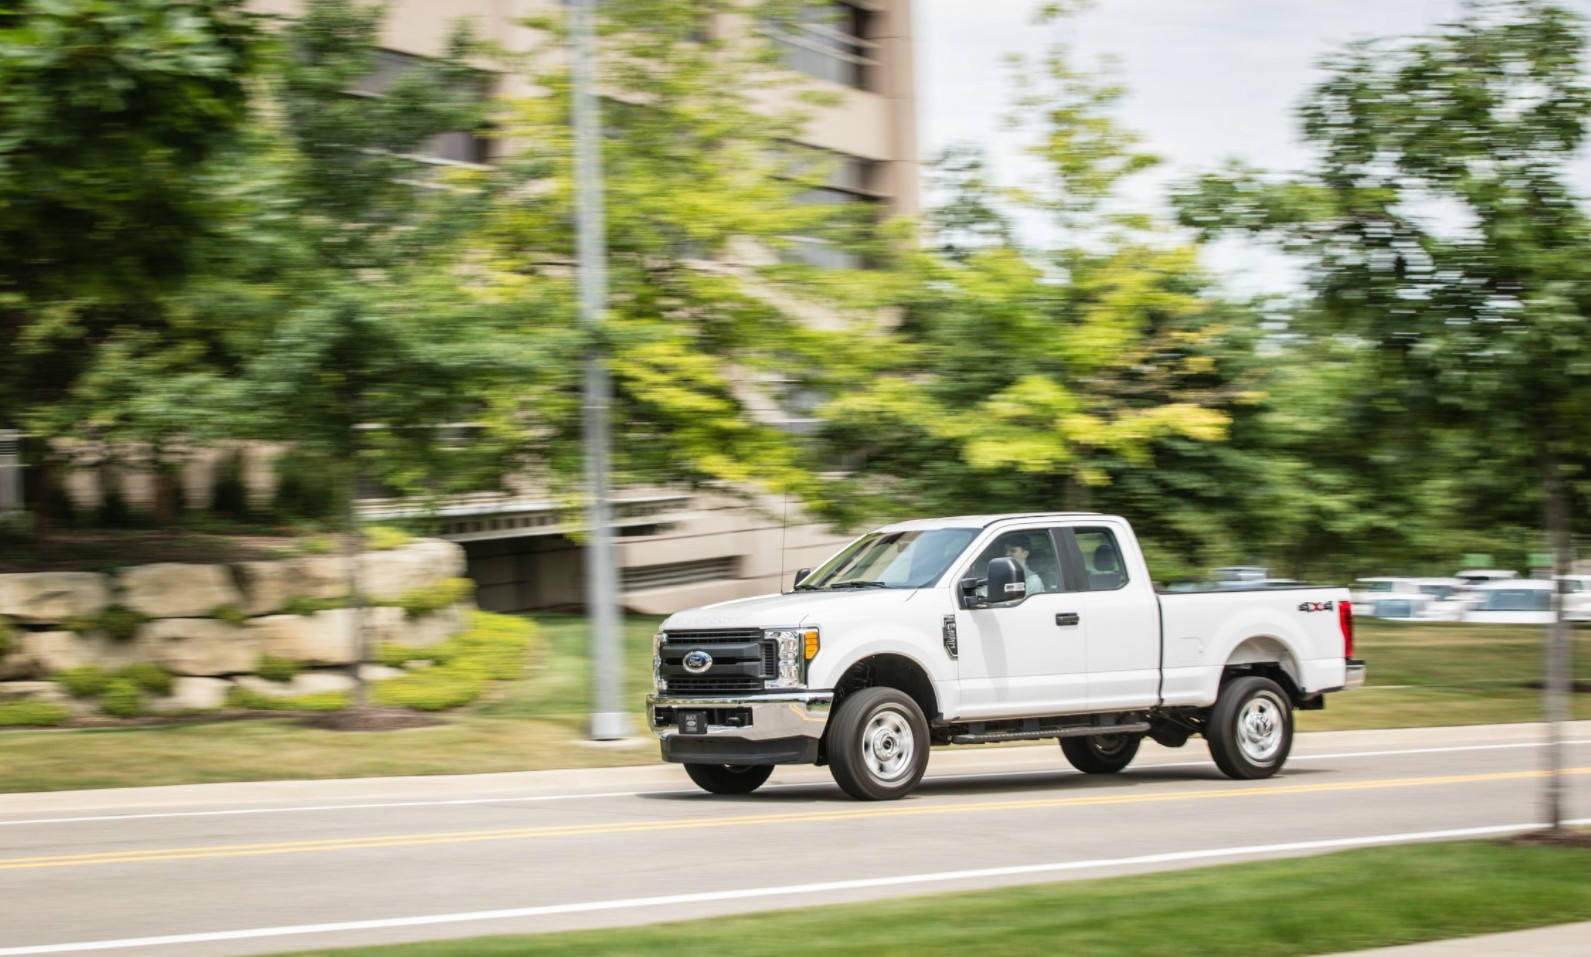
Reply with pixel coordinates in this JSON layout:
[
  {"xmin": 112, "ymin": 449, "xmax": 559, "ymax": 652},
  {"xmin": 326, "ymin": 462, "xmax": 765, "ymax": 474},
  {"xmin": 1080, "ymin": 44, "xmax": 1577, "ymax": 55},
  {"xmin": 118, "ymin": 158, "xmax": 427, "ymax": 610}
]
[{"xmin": 0, "ymin": 817, "xmax": 1591, "ymax": 957}]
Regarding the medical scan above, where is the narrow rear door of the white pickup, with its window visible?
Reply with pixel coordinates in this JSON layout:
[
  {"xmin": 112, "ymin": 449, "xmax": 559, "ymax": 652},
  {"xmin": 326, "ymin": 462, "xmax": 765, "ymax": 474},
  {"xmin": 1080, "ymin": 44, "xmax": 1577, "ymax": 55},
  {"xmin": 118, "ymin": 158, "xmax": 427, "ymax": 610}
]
[{"xmin": 1056, "ymin": 525, "xmax": 1160, "ymax": 711}]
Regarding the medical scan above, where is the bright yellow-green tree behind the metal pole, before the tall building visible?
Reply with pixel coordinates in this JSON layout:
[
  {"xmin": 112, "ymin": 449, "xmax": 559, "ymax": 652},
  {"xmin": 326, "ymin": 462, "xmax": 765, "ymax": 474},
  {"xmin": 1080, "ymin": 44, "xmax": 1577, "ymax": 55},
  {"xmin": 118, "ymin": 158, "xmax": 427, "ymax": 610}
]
[{"xmin": 492, "ymin": 0, "xmax": 888, "ymax": 498}]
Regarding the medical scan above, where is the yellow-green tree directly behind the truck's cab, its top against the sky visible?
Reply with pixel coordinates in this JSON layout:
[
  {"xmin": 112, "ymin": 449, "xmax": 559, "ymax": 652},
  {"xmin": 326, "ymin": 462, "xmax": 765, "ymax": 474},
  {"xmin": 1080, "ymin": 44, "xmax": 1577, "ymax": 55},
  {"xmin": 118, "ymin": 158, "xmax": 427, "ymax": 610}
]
[{"xmin": 824, "ymin": 48, "xmax": 1257, "ymax": 572}]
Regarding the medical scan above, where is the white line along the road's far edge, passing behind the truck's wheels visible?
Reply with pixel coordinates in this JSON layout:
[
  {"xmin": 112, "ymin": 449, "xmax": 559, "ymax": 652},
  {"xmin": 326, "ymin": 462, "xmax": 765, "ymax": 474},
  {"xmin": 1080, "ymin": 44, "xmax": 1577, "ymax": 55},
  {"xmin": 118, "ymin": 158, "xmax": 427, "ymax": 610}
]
[{"xmin": 0, "ymin": 738, "xmax": 1591, "ymax": 827}]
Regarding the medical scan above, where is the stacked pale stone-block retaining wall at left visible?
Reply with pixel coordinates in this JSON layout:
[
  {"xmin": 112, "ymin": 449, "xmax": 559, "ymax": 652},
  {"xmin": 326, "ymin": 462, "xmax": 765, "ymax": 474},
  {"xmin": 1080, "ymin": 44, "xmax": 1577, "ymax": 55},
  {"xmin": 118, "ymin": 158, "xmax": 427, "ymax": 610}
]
[{"xmin": 0, "ymin": 539, "xmax": 473, "ymax": 711}]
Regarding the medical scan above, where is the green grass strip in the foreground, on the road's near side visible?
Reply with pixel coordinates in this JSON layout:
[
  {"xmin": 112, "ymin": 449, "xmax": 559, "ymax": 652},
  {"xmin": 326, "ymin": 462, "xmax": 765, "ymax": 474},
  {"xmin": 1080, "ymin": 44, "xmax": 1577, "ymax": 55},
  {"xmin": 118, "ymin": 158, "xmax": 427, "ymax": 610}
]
[{"xmin": 267, "ymin": 843, "xmax": 1591, "ymax": 957}]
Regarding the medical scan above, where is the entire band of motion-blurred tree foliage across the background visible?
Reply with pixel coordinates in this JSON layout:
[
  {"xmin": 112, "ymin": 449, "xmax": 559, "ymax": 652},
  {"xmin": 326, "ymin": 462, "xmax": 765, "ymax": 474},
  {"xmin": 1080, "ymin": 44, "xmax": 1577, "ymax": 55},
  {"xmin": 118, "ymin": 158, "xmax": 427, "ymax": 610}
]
[{"xmin": 0, "ymin": 0, "xmax": 1591, "ymax": 579}]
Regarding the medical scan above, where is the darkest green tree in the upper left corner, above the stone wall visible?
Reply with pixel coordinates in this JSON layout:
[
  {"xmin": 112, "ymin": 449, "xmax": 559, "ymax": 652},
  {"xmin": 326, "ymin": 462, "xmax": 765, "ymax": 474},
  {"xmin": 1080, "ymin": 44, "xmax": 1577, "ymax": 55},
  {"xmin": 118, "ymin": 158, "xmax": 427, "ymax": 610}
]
[{"xmin": 0, "ymin": 0, "xmax": 261, "ymax": 531}]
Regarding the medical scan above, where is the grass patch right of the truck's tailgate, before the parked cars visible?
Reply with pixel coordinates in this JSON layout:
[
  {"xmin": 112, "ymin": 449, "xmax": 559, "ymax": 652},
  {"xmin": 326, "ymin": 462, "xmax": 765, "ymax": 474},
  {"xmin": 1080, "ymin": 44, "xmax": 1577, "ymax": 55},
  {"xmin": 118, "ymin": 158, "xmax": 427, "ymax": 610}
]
[{"xmin": 1298, "ymin": 620, "xmax": 1591, "ymax": 731}]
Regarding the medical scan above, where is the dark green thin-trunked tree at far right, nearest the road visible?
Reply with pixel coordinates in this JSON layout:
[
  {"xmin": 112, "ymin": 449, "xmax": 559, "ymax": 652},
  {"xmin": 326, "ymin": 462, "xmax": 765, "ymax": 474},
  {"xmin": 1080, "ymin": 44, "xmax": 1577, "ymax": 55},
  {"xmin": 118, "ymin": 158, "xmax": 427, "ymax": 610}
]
[{"xmin": 1181, "ymin": 0, "xmax": 1591, "ymax": 820}]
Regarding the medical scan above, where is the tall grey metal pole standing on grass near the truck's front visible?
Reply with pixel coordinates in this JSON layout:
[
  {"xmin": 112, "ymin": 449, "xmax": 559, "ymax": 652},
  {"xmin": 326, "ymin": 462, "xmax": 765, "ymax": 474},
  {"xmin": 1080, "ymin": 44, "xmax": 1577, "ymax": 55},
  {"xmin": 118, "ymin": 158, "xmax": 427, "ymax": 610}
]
[{"xmin": 570, "ymin": 0, "xmax": 630, "ymax": 741}]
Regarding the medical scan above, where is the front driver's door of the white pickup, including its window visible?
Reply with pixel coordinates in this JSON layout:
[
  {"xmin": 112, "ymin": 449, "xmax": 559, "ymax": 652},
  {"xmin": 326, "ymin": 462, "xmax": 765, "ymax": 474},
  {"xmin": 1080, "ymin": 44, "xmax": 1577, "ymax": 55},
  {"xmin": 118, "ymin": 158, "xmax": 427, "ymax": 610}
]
[{"xmin": 956, "ymin": 528, "xmax": 1088, "ymax": 719}]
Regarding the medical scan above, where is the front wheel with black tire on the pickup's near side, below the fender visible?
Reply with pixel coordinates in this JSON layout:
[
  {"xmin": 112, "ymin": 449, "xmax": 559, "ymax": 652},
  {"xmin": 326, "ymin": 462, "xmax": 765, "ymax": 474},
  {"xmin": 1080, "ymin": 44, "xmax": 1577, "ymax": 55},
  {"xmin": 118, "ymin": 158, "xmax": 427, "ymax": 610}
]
[{"xmin": 827, "ymin": 688, "xmax": 931, "ymax": 801}]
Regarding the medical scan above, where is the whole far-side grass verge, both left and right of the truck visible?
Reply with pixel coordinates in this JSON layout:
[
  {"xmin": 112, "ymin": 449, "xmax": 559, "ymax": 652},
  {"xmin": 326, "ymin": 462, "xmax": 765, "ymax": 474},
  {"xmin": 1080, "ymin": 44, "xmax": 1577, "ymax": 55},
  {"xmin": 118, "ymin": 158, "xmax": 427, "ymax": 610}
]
[{"xmin": 0, "ymin": 615, "xmax": 1591, "ymax": 792}]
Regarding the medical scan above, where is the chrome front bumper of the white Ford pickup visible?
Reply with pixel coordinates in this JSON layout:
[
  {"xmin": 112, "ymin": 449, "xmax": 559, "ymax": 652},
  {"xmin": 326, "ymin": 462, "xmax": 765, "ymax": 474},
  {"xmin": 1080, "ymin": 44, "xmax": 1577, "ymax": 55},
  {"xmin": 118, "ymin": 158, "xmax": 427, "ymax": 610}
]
[{"xmin": 646, "ymin": 692, "xmax": 834, "ymax": 765}]
